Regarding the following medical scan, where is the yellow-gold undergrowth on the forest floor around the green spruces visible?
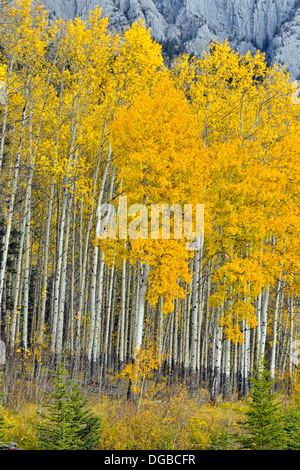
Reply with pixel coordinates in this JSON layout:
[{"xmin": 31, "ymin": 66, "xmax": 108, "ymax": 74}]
[{"xmin": 0, "ymin": 370, "xmax": 289, "ymax": 451}]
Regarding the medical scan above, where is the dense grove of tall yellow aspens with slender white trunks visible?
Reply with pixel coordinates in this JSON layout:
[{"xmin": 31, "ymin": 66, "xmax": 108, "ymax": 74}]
[{"xmin": 0, "ymin": 0, "xmax": 300, "ymax": 399}]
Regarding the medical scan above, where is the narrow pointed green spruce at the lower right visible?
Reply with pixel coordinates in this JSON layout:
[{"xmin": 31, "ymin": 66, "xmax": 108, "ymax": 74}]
[{"xmin": 237, "ymin": 360, "xmax": 287, "ymax": 450}]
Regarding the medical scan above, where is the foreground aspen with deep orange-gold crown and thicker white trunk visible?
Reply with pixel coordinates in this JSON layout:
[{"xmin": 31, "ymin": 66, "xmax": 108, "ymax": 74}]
[{"xmin": 112, "ymin": 73, "xmax": 206, "ymax": 370}]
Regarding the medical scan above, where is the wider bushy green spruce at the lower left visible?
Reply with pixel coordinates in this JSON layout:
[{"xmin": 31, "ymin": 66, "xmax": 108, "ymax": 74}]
[{"xmin": 37, "ymin": 365, "xmax": 101, "ymax": 450}]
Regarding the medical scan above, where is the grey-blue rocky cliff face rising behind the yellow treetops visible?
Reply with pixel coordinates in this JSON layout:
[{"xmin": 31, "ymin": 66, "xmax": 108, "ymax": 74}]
[{"xmin": 43, "ymin": 0, "xmax": 300, "ymax": 78}]
